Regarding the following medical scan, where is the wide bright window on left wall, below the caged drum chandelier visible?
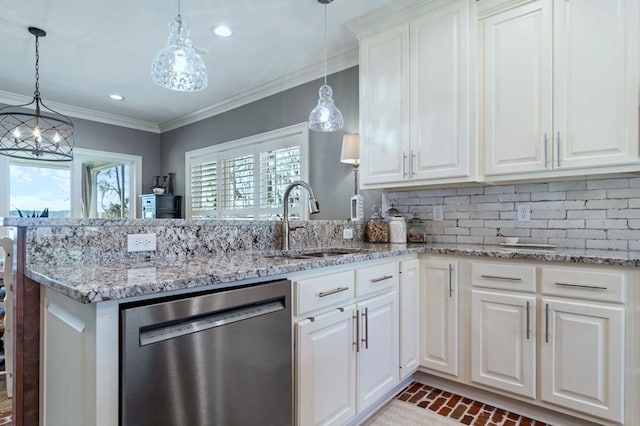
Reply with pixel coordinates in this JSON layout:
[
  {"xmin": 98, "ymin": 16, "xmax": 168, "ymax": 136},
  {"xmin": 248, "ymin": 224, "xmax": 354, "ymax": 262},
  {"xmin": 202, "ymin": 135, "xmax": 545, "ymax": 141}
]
[{"xmin": 0, "ymin": 148, "xmax": 142, "ymax": 221}]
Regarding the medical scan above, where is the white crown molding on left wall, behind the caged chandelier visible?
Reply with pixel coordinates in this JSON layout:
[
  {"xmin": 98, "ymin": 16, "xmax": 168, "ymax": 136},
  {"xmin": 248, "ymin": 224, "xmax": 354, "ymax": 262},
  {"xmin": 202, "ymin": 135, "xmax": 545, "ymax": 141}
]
[{"xmin": 0, "ymin": 90, "xmax": 160, "ymax": 133}]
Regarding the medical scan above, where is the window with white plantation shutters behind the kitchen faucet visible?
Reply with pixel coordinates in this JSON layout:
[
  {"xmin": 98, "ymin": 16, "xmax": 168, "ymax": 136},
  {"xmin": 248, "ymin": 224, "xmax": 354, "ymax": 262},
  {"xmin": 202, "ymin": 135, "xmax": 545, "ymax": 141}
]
[{"xmin": 186, "ymin": 123, "xmax": 309, "ymax": 219}]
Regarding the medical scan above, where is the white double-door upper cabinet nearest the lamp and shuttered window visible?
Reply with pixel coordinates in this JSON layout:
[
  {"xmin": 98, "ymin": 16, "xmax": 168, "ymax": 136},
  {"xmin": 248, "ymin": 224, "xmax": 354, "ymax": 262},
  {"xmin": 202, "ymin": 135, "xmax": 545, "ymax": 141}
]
[{"xmin": 360, "ymin": 0, "xmax": 475, "ymax": 188}]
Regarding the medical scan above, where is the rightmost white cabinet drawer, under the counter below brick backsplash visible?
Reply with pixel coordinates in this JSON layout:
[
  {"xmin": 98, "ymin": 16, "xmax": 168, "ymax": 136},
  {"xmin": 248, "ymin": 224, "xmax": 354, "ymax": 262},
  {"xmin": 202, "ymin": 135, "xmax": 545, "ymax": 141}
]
[{"xmin": 542, "ymin": 267, "xmax": 626, "ymax": 303}]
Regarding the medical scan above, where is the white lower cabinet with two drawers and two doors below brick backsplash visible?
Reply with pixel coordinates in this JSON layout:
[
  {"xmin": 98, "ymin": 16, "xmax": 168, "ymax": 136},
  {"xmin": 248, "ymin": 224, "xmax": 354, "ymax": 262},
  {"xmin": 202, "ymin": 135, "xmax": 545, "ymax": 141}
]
[{"xmin": 460, "ymin": 261, "xmax": 640, "ymax": 424}]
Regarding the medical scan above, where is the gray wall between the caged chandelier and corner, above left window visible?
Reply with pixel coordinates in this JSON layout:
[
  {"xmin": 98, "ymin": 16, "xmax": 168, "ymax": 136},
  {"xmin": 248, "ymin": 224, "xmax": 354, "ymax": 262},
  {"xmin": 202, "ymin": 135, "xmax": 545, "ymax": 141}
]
[{"xmin": 72, "ymin": 117, "xmax": 162, "ymax": 194}]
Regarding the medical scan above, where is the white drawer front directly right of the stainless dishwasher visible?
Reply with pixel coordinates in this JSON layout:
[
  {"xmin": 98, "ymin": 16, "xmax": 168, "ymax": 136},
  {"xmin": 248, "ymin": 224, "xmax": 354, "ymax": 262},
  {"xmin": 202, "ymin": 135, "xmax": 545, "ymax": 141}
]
[{"xmin": 293, "ymin": 271, "xmax": 354, "ymax": 315}]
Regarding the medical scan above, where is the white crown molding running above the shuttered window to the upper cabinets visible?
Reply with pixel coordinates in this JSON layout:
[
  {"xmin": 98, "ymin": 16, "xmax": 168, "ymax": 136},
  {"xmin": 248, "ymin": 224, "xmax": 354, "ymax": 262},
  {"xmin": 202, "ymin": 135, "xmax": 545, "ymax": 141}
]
[{"xmin": 159, "ymin": 48, "xmax": 358, "ymax": 133}]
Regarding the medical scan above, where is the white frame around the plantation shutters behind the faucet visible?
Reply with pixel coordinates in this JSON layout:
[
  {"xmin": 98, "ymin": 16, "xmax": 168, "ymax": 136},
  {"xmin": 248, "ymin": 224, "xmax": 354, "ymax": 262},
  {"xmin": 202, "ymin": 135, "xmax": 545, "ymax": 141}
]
[{"xmin": 185, "ymin": 122, "xmax": 309, "ymax": 220}]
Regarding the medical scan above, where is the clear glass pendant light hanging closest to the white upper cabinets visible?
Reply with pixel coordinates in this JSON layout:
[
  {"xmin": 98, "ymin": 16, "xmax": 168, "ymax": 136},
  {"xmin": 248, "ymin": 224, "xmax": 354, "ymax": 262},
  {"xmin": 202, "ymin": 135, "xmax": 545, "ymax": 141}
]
[{"xmin": 309, "ymin": 0, "xmax": 344, "ymax": 132}]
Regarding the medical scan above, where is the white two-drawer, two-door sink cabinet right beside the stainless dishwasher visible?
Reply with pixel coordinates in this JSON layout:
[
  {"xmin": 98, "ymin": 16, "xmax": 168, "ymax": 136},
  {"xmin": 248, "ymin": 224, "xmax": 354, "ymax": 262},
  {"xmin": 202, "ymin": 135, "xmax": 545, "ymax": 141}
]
[{"xmin": 293, "ymin": 261, "xmax": 400, "ymax": 426}]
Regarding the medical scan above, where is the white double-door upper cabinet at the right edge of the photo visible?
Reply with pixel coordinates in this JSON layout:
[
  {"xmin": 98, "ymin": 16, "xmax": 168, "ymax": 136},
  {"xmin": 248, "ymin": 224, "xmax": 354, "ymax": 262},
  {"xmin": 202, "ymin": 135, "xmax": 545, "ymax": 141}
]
[{"xmin": 479, "ymin": 0, "xmax": 639, "ymax": 177}]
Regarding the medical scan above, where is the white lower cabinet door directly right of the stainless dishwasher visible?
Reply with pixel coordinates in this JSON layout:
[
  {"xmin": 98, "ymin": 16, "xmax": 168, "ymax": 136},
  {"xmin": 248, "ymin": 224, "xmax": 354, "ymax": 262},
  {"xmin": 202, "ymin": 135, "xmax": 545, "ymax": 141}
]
[{"xmin": 296, "ymin": 305, "xmax": 356, "ymax": 425}]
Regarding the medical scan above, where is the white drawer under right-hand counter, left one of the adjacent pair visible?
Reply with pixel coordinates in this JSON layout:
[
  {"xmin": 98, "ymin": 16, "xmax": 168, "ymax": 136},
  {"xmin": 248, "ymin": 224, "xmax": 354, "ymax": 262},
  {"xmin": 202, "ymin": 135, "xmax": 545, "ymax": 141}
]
[{"xmin": 471, "ymin": 263, "xmax": 536, "ymax": 293}]
